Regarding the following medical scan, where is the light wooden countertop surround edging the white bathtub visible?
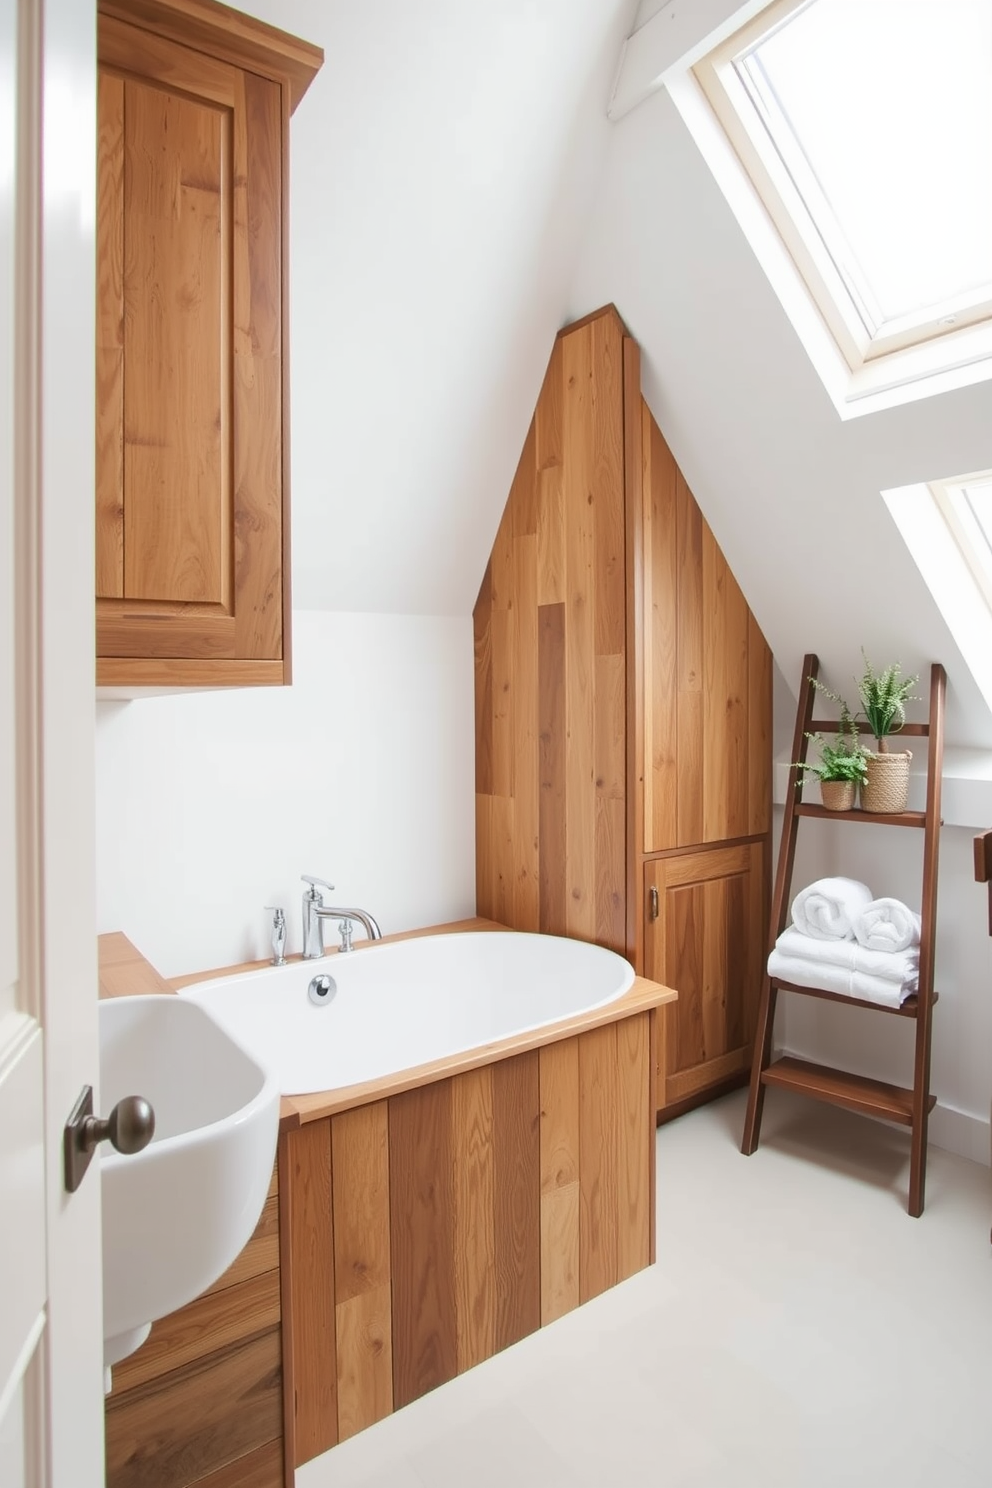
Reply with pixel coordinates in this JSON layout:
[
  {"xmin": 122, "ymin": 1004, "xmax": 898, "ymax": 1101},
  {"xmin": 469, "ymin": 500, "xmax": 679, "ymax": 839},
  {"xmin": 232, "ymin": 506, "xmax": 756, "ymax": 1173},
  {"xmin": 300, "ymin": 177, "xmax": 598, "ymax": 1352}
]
[{"xmin": 98, "ymin": 917, "xmax": 678, "ymax": 1131}]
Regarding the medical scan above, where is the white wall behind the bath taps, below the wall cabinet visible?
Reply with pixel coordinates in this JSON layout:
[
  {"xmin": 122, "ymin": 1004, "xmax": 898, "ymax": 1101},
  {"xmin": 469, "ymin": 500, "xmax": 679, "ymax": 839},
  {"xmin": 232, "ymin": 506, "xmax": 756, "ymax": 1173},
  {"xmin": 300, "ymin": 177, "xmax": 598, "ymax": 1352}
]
[{"xmin": 97, "ymin": 612, "xmax": 476, "ymax": 976}]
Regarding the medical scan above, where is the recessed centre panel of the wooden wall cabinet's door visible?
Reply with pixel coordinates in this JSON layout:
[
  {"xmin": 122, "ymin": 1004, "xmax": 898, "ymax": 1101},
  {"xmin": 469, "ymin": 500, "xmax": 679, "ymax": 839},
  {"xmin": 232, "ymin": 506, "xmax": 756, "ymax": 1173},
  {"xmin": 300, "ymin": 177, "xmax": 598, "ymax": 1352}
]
[{"xmin": 123, "ymin": 79, "xmax": 231, "ymax": 604}]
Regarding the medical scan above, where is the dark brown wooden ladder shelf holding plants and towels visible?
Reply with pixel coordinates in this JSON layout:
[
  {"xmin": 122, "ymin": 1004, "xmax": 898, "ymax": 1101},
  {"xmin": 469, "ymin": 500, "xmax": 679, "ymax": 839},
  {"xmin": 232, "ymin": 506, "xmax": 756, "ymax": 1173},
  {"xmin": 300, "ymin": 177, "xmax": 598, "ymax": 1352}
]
[{"xmin": 741, "ymin": 655, "xmax": 946, "ymax": 1217}]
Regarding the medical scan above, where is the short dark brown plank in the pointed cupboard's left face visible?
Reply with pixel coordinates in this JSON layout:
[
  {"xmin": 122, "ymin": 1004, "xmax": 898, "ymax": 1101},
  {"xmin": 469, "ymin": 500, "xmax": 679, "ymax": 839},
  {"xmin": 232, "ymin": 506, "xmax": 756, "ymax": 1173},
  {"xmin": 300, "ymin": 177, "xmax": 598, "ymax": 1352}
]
[{"xmin": 537, "ymin": 604, "xmax": 567, "ymax": 934}]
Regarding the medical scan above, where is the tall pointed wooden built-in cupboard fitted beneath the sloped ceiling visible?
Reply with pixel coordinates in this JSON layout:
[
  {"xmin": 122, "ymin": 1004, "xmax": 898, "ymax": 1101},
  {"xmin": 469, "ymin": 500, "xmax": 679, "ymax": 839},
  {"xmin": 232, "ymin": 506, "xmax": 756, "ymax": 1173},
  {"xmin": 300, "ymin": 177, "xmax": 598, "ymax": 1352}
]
[{"xmin": 474, "ymin": 307, "xmax": 772, "ymax": 1116}]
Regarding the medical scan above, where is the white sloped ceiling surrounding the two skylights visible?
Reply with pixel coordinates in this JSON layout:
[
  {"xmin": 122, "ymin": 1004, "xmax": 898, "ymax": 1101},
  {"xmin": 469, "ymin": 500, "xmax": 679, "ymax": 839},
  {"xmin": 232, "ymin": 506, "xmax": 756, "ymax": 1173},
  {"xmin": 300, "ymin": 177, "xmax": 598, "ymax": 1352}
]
[{"xmin": 568, "ymin": 3, "xmax": 992, "ymax": 747}]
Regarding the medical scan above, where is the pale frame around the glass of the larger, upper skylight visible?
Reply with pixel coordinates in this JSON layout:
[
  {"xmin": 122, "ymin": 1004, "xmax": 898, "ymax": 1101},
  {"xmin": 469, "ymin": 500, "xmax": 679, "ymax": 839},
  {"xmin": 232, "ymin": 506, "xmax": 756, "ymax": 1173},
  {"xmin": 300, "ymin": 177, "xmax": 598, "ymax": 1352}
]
[{"xmin": 692, "ymin": 0, "xmax": 992, "ymax": 373}]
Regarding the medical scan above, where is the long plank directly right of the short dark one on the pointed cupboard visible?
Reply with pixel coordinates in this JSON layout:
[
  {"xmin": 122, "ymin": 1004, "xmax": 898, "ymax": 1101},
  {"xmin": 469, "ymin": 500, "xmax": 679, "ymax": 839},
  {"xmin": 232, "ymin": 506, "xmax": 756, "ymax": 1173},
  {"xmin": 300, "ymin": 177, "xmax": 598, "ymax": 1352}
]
[{"xmin": 562, "ymin": 324, "xmax": 599, "ymax": 940}]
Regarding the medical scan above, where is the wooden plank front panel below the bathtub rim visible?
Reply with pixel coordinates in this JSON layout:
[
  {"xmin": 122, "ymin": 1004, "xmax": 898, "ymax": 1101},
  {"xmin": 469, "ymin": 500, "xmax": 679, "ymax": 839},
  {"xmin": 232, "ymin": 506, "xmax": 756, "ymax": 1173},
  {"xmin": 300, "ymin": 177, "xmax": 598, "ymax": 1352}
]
[{"xmin": 280, "ymin": 1010, "xmax": 659, "ymax": 1466}]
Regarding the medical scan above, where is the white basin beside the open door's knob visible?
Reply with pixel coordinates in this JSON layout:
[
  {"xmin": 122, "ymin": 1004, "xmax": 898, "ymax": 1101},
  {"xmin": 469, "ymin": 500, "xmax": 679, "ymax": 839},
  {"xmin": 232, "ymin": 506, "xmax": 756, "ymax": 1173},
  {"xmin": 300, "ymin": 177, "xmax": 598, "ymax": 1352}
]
[{"xmin": 100, "ymin": 994, "xmax": 280, "ymax": 1364}]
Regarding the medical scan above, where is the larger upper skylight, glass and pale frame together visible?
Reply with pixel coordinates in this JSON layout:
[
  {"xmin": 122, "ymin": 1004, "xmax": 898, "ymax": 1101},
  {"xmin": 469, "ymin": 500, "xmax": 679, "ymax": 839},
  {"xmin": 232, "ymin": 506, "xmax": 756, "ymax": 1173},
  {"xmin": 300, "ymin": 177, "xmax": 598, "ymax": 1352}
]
[{"xmin": 693, "ymin": 0, "xmax": 992, "ymax": 404}]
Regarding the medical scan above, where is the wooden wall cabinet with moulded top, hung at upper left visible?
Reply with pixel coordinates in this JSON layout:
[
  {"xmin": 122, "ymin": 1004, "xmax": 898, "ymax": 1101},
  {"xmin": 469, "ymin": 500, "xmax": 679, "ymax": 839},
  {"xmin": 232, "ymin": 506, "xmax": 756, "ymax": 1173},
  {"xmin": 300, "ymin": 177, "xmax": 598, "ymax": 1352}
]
[{"xmin": 97, "ymin": 0, "xmax": 323, "ymax": 687}]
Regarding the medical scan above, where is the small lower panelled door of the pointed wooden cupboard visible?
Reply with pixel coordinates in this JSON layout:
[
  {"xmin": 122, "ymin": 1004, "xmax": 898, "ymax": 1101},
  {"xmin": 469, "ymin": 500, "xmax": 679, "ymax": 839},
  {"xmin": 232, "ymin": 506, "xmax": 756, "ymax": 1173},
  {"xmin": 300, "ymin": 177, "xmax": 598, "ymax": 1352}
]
[{"xmin": 644, "ymin": 842, "xmax": 767, "ymax": 1110}]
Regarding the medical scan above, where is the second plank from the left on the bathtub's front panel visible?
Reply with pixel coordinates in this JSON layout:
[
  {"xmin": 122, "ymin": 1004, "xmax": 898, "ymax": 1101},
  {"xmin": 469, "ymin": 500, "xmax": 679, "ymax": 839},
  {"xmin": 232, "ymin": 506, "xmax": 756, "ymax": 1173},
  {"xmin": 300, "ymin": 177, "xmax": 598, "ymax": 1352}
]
[{"xmin": 330, "ymin": 1101, "xmax": 393, "ymax": 1440}]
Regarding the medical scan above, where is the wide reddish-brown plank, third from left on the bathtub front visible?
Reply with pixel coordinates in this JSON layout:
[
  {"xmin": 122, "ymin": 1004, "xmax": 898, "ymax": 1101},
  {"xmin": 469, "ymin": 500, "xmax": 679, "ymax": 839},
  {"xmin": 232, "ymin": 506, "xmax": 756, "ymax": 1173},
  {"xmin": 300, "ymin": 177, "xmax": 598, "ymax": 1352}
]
[{"xmin": 390, "ymin": 1080, "xmax": 458, "ymax": 1409}]
